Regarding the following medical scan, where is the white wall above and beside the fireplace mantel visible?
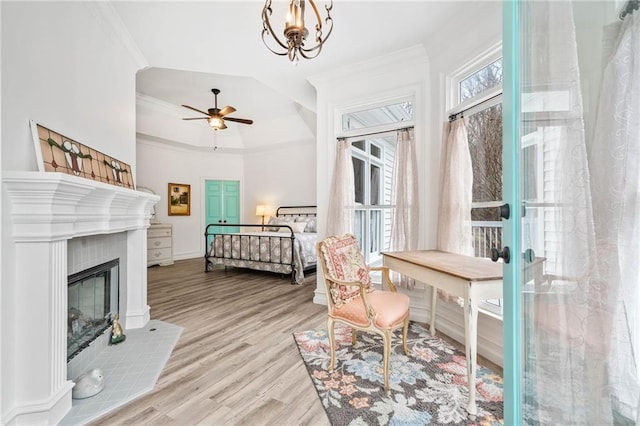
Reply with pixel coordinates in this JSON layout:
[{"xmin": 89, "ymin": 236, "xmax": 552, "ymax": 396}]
[{"xmin": 0, "ymin": 2, "xmax": 140, "ymax": 424}]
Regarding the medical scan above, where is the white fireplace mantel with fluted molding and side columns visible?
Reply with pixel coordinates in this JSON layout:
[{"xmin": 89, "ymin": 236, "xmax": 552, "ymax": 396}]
[{"xmin": 0, "ymin": 172, "xmax": 160, "ymax": 424}]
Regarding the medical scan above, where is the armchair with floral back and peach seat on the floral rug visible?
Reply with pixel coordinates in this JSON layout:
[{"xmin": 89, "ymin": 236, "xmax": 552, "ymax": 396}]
[{"xmin": 317, "ymin": 234, "xmax": 409, "ymax": 394}]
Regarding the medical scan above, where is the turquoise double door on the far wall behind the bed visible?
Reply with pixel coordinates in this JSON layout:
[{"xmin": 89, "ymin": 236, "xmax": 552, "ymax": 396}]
[{"xmin": 205, "ymin": 180, "xmax": 240, "ymax": 247}]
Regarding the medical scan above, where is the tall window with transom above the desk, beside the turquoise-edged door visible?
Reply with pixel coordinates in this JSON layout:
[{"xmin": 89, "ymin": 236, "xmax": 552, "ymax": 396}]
[{"xmin": 453, "ymin": 51, "xmax": 502, "ymax": 315}]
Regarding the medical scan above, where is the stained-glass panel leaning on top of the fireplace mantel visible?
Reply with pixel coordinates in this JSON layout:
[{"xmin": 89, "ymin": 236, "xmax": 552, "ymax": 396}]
[{"xmin": 30, "ymin": 120, "xmax": 135, "ymax": 189}]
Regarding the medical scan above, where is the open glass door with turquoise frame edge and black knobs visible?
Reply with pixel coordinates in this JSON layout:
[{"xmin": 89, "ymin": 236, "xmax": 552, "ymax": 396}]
[{"xmin": 502, "ymin": 0, "xmax": 640, "ymax": 425}]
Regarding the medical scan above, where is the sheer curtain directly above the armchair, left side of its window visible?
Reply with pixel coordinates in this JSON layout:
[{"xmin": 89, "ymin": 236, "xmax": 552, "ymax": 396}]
[{"xmin": 327, "ymin": 139, "xmax": 355, "ymax": 235}]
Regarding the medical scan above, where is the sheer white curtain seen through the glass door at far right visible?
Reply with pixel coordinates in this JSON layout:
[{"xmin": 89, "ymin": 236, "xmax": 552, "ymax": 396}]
[{"xmin": 522, "ymin": 0, "xmax": 640, "ymax": 425}]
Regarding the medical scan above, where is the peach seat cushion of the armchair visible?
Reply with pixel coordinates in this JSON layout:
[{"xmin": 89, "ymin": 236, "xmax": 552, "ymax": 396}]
[{"xmin": 331, "ymin": 290, "xmax": 409, "ymax": 329}]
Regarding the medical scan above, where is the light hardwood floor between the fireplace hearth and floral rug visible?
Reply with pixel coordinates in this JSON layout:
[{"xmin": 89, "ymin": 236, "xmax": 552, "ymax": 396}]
[{"xmin": 92, "ymin": 259, "xmax": 329, "ymax": 425}]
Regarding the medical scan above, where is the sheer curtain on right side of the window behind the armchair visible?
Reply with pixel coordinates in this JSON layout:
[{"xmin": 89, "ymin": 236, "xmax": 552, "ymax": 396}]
[{"xmin": 390, "ymin": 129, "xmax": 419, "ymax": 288}]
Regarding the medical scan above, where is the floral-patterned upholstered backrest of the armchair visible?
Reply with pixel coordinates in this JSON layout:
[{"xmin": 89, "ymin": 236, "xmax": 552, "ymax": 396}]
[{"xmin": 320, "ymin": 234, "xmax": 373, "ymax": 307}]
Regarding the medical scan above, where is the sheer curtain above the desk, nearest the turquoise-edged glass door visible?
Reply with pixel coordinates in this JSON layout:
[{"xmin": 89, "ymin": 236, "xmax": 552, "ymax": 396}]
[{"xmin": 436, "ymin": 118, "xmax": 473, "ymax": 256}]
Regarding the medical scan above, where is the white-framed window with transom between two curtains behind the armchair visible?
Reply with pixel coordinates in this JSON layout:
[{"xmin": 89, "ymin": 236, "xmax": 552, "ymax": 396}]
[{"xmin": 340, "ymin": 99, "xmax": 413, "ymax": 265}]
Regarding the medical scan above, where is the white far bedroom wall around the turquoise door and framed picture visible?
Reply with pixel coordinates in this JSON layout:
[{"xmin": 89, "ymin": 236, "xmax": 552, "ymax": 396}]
[{"xmin": 136, "ymin": 139, "xmax": 316, "ymax": 260}]
